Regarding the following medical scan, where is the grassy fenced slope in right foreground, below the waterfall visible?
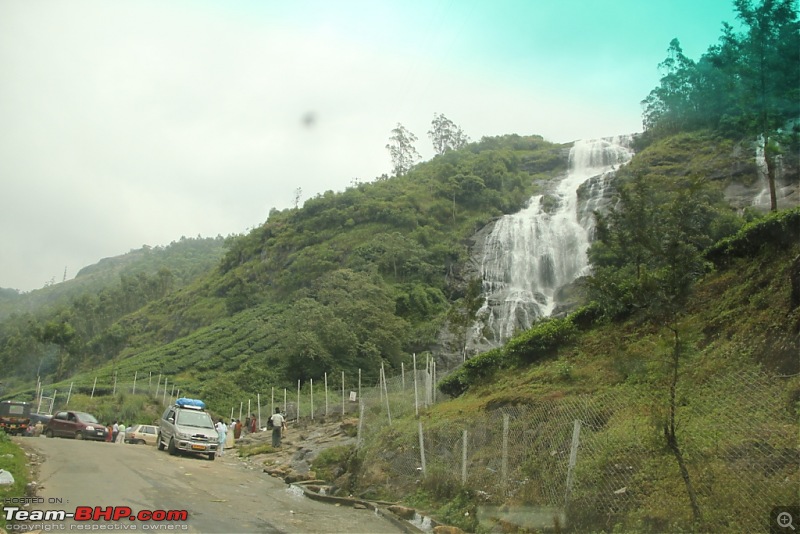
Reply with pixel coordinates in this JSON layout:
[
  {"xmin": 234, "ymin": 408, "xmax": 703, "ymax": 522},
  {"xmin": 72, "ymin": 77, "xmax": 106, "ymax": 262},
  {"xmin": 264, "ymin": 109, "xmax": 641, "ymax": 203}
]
[{"xmin": 346, "ymin": 215, "xmax": 800, "ymax": 532}]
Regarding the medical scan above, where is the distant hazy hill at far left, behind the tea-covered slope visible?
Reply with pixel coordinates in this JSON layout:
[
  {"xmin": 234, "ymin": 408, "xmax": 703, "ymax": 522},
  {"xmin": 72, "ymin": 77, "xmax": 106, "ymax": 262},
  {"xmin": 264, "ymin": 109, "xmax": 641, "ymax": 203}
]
[{"xmin": 0, "ymin": 237, "xmax": 225, "ymax": 389}]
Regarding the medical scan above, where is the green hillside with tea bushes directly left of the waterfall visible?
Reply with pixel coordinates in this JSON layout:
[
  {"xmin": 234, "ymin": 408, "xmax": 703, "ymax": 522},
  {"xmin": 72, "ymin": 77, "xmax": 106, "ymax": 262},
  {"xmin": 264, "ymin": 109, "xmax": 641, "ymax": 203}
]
[{"xmin": 0, "ymin": 135, "xmax": 566, "ymax": 400}]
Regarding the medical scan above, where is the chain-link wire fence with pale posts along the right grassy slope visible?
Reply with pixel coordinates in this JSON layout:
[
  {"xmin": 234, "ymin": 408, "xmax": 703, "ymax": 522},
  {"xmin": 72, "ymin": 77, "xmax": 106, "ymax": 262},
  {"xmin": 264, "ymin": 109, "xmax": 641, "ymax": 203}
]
[{"xmin": 359, "ymin": 371, "xmax": 800, "ymax": 532}]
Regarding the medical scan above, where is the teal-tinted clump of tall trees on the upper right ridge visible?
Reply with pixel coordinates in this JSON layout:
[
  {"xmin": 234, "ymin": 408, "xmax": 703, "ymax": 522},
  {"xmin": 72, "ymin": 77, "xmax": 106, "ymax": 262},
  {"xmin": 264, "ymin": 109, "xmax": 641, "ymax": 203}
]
[{"xmin": 642, "ymin": 0, "xmax": 800, "ymax": 201}]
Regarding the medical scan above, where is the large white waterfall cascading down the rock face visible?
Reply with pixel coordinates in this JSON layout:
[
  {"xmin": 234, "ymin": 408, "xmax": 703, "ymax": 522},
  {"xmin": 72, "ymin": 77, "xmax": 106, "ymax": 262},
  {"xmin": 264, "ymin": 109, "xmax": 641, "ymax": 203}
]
[{"xmin": 466, "ymin": 137, "xmax": 632, "ymax": 352}]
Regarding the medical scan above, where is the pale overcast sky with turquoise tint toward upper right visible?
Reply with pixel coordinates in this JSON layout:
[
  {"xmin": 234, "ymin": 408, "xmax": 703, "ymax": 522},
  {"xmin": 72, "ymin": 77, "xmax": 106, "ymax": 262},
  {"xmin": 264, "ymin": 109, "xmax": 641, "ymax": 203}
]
[{"xmin": 0, "ymin": 0, "xmax": 735, "ymax": 291}]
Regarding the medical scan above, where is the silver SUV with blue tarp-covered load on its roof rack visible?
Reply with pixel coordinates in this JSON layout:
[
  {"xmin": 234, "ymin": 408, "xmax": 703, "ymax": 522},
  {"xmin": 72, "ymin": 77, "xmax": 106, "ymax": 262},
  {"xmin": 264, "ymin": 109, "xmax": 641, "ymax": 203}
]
[{"xmin": 157, "ymin": 398, "xmax": 219, "ymax": 460}]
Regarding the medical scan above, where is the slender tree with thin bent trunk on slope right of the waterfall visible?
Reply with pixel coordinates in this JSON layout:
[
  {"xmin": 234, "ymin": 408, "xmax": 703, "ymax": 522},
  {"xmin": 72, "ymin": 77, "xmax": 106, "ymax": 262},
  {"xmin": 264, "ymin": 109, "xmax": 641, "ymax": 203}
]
[{"xmin": 589, "ymin": 174, "xmax": 740, "ymax": 525}]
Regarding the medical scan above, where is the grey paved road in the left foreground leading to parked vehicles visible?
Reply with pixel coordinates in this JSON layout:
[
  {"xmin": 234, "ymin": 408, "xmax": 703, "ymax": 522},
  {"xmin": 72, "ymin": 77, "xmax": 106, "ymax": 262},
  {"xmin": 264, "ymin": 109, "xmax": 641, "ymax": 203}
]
[{"xmin": 14, "ymin": 437, "xmax": 402, "ymax": 534}]
